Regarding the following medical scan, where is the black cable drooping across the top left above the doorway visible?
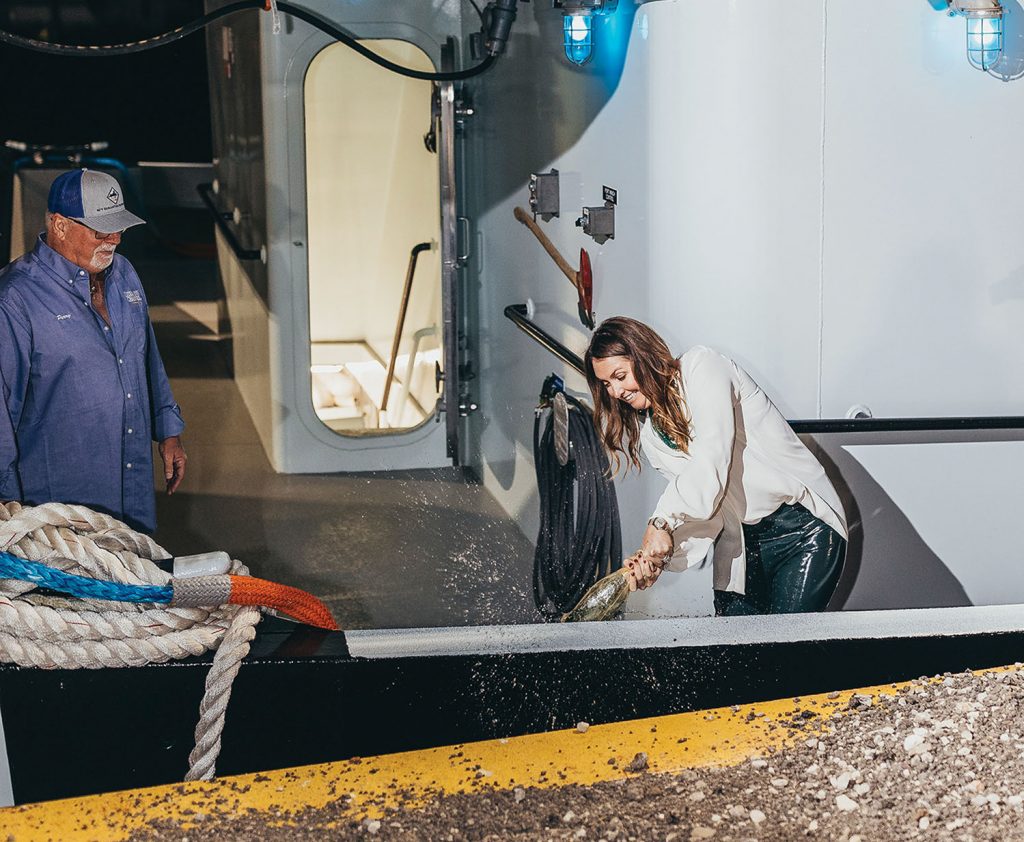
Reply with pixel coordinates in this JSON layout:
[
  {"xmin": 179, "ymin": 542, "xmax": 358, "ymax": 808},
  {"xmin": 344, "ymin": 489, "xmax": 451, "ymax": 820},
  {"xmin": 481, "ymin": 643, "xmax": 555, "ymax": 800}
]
[{"xmin": 0, "ymin": 0, "xmax": 496, "ymax": 82}]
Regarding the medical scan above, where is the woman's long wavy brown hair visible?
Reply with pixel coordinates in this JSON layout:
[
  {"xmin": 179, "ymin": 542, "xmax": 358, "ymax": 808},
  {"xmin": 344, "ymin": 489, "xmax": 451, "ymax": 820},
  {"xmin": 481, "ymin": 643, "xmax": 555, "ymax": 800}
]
[{"xmin": 584, "ymin": 315, "xmax": 690, "ymax": 471}]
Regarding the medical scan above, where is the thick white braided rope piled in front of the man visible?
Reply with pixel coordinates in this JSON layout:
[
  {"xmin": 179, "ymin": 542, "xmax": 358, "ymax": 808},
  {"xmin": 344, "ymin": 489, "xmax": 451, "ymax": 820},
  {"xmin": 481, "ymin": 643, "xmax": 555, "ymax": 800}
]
[{"xmin": 0, "ymin": 502, "xmax": 260, "ymax": 781}]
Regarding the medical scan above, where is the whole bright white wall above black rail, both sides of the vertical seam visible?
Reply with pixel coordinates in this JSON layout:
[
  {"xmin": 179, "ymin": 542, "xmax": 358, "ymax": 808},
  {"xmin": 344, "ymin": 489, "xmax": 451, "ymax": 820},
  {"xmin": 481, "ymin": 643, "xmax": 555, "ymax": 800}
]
[{"xmin": 641, "ymin": 0, "xmax": 1024, "ymax": 418}]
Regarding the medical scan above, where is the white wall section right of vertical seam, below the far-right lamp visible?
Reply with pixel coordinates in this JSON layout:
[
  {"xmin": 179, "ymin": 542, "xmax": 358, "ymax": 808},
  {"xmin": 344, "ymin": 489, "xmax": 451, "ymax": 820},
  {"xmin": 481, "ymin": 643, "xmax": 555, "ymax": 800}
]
[{"xmin": 821, "ymin": 2, "xmax": 1024, "ymax": 417}]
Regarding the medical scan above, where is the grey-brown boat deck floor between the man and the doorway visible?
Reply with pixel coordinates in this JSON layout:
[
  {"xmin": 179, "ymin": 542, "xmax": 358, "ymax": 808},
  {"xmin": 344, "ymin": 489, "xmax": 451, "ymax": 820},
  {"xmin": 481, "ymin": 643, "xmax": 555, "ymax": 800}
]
[{"xmin": 128, "ymin": 222, "xmax": 540, "ymax": 629}]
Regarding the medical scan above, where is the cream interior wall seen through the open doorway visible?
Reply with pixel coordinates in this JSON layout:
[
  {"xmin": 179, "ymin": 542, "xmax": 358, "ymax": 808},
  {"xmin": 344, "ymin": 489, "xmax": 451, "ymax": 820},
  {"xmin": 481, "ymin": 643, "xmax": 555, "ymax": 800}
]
[{"xmin": 305, "ymin": 40, "xmax": 440, "ymax": 360}]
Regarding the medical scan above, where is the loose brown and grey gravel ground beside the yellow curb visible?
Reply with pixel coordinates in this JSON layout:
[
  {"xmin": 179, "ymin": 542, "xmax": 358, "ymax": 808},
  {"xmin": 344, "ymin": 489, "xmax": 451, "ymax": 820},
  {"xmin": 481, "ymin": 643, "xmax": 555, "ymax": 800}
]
[{"xmin": 132, "ymin": 664, "xmax": 1024, "ymax": 842}]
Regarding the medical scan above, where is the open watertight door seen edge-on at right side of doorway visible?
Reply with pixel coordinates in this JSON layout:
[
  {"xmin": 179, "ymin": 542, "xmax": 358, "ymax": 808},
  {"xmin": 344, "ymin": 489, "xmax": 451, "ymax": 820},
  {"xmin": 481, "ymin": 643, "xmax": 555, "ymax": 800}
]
[{"xmin": 437, "ymin": 40, "xmax": 463, "ymax": 465}]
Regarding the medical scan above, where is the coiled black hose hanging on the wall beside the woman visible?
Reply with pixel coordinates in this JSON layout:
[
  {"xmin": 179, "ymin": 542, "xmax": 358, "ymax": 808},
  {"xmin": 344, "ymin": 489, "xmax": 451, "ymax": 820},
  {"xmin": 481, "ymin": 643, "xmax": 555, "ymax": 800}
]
[{"xmin": 534, "ymin": 395, "xmax": 623, "ymax": 620}]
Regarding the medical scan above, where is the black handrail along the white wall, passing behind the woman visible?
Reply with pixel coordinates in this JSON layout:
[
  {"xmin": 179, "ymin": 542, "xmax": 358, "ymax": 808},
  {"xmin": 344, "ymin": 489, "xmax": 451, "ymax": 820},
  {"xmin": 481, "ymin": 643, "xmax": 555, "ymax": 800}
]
[{"xmin": 505, "ymin": 304, "xmax": 1024, "ymax": 433}]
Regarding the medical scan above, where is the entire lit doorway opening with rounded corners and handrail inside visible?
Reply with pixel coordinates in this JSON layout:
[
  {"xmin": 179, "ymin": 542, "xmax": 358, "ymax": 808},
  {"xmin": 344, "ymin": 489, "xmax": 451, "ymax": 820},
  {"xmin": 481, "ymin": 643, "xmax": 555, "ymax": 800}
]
[{"xmin": 304, "ymin": 40, "xmax": 442, "ymax": 435}]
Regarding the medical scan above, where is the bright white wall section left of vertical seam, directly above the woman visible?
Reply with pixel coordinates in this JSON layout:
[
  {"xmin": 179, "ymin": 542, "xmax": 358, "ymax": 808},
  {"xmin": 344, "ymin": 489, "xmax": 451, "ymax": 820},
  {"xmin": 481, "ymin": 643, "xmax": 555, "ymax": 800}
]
[{"xmin": 647, "ymin": 0, "xmax": 822, "ymax": 418}]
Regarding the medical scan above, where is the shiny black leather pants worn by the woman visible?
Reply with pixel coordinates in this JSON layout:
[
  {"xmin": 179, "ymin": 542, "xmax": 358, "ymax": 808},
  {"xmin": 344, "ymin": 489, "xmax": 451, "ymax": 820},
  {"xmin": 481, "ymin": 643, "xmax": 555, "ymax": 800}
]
[{"xmin": 715, "ymin": 505, "xmax": 846, "ymax": 617}]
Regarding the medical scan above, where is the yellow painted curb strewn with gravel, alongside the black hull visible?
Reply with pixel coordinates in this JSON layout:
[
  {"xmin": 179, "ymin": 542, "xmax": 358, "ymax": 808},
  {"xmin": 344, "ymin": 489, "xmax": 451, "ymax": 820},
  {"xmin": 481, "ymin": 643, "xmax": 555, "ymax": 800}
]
[{"xmin": 0, "ymin": 670, "xmax": 993, "ymax": 842}]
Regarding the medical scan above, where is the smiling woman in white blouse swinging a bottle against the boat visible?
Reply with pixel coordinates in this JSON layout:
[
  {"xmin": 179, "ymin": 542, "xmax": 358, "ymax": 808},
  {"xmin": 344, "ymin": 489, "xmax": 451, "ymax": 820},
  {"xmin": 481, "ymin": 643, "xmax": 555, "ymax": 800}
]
[{"xmin": 585, "ymin": 317, "xmax": 847, "ymax": 616}]
